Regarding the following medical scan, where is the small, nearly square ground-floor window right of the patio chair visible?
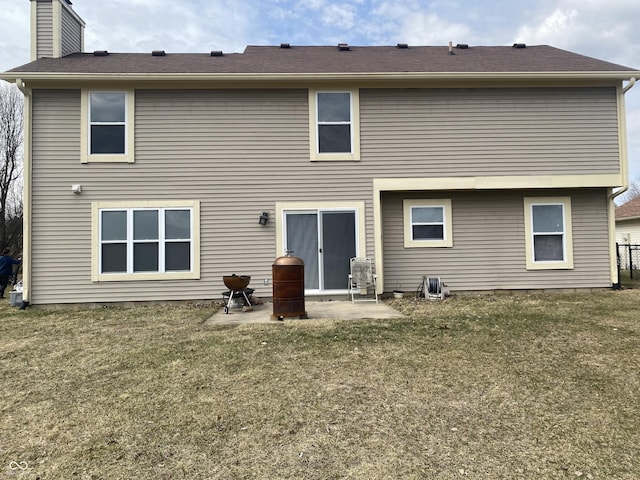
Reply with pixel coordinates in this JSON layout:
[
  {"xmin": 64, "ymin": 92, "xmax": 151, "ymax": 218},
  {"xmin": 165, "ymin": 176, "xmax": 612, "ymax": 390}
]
[{"xmin": 403, "ymin": 199, "xmax": 453, "ymax": 248}]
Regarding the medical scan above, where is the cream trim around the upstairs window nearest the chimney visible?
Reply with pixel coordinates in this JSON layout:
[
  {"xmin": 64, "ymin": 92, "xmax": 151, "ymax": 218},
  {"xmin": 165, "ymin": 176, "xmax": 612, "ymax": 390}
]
[{"xmin": 80, "ymin": 89, "xmax": 136, "ymax": 163}]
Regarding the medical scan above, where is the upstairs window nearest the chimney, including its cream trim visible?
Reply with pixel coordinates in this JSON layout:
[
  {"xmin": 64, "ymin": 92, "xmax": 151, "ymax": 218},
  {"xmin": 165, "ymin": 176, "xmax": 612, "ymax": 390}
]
[{"xmin": 82, "ymin": 90, "xmax": 135, "ymax": 163}]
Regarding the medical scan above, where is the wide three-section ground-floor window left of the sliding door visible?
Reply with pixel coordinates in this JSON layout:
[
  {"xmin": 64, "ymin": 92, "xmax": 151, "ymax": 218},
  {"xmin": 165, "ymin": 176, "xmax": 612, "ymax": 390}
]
[{"xmin": 94, "ymin": 202, "xmax": 199, "ymax": 281}]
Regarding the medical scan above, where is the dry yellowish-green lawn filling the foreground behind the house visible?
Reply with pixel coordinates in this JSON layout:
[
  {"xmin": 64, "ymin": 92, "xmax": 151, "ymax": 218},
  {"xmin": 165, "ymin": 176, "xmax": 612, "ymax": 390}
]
[{"xmin": 0, "ymin": 290, "xmax": 640, "ymax": 480}]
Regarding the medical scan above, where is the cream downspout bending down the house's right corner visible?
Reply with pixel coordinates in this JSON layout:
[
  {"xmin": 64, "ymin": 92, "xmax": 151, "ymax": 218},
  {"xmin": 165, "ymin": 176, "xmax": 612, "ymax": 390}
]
[{"xmin": 609, "ymin": 77, "xmax": 636, "ymax": 290}]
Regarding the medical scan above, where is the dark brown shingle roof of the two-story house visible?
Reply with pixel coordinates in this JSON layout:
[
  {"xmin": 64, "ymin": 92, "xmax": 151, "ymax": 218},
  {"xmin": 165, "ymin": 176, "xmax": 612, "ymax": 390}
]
[{"xmin": 8, "ymin": 46, "xmax": 635, "ymax": 74}]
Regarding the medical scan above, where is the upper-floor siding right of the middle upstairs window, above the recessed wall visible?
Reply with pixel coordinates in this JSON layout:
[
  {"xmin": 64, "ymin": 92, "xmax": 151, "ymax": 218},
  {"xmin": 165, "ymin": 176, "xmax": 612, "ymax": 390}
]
[{"xmin": 360, "ymin": 88, "xmax": 619, "ymax": 177}]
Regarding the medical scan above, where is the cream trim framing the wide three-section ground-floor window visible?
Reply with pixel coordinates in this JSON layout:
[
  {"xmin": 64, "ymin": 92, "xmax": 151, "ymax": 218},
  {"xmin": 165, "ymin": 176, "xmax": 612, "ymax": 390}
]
[{"xmin": 91, "ymin": 200, "xmax": 200, "ymax": 282}]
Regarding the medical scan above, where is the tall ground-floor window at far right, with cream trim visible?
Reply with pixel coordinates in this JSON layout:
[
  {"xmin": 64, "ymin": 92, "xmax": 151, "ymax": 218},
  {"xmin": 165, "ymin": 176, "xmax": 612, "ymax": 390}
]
[{"xmin": 524, "ymin": 197, "xmax": 573, "ymax": 270}]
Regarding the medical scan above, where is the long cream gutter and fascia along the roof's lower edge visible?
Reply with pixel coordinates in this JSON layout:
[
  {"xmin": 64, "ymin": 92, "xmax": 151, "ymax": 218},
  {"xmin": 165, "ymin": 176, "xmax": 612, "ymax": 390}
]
[{"xmin": 0, "ymin": 70, "xmax": 640, "ymax": 82}]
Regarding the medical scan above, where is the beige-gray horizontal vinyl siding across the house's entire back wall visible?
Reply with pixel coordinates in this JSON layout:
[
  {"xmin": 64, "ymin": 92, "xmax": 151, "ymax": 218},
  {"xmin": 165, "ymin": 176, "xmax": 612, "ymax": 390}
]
[{"xmin": 30, "ymin": 86, "xmax": 618, "ymax": 304}]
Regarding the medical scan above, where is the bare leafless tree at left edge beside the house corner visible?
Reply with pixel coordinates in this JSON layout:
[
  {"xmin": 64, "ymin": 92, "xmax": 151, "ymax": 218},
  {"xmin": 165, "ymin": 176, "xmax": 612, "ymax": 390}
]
[{"xmin": 0, "ymin": 82, "xmax": 24, "ymax": 249}]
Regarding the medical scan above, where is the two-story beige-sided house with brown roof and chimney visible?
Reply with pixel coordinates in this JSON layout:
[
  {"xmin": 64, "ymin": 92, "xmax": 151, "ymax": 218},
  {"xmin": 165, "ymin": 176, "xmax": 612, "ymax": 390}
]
[{"xmin": 0, "ymin": 0, "xmax": 640, "ymax": 304}]
